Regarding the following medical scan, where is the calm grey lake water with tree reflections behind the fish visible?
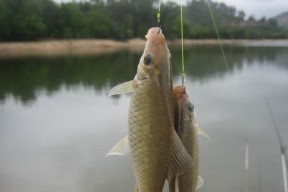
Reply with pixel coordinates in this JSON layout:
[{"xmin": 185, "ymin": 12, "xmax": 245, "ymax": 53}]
[{"xmin": 0, "ymin": 46, "xmax": 288, "ymax": 192}]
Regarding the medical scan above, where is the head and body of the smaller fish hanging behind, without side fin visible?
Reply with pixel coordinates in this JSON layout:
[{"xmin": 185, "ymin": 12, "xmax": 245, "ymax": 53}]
[{"xmin": 173, "ymin": 85, "xmax": 203, "ymax": 192}]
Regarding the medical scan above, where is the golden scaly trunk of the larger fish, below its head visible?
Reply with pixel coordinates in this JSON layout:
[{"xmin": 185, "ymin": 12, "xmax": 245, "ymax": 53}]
[{"xmin": 128, "ymin": 80, "xmax": 171, "ymax": 192}]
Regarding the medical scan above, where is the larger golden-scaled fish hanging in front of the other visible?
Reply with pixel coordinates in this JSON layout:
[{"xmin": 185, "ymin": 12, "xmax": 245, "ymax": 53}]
[{"xmin": 109, "ymin": 27, "xmax": 194, "ymax": 192}]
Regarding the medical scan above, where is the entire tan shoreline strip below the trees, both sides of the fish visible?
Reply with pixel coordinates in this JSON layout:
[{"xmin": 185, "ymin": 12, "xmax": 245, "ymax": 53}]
[{"xmin": 0, "ymin": 39, "xmax": 288, "ymax": 58}]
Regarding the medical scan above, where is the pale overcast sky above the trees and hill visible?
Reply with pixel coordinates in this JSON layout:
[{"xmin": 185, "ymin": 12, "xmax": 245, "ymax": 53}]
[{"xmin": 54, "ymin": 0, "xmax": 288, "ymax": 19}]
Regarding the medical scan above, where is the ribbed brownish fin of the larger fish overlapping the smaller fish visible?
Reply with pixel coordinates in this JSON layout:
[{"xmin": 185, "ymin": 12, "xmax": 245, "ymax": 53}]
[{"xmin": 167, "ymin": 131, "xmax": 194, "ymax": 181}]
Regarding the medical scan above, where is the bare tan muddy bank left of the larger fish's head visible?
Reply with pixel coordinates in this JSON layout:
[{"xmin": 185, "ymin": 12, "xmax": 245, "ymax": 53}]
[{"xmin": 0, "ymin": 40, "xmax": 145, "ymax": 57}]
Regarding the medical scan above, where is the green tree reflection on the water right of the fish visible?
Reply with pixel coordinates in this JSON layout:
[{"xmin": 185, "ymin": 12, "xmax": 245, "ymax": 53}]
[{"xmin": 177, "ymin": 46, "xmax": 288, "ymax": 81}]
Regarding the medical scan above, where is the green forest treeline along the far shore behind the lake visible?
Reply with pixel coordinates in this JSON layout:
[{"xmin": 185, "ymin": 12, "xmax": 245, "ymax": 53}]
[{"xmin": 0, "ymin": 0, "xmax": 287, "ymax": 41}]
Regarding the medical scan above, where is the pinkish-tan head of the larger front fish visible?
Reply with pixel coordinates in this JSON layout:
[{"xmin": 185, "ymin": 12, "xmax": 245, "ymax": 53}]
[{"xmin": 137, "ymin": 27, "xmax": 172, "ymax": 89}]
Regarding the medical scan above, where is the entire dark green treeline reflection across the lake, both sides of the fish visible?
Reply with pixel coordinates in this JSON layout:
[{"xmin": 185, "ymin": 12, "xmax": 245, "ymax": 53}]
[{"xmin": 0, "ymin": 46, "xmax": 288, "ymax": 104}]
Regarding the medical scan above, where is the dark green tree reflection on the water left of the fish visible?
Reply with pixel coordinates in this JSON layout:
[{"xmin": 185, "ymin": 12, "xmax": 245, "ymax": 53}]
[{"xmin": 0, "ymin": 52, "xmax": 139, "ymax": 103}]
